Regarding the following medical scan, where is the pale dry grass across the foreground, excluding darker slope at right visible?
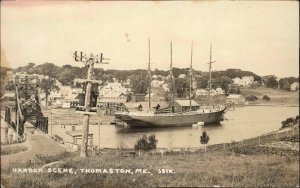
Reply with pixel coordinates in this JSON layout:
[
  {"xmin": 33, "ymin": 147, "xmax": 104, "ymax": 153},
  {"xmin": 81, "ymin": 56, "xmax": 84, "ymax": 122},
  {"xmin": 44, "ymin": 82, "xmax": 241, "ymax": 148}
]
[{"xmin": 1, "ymin": 144, "xmax": 299, "ymax": 187}]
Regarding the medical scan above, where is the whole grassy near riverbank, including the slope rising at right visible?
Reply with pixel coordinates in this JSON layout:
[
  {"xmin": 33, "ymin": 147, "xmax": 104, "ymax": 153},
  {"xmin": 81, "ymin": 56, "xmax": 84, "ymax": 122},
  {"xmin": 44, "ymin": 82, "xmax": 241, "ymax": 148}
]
[{"xmin": 1, "ymin": 125, "xmax": 299, "ymax": 187}]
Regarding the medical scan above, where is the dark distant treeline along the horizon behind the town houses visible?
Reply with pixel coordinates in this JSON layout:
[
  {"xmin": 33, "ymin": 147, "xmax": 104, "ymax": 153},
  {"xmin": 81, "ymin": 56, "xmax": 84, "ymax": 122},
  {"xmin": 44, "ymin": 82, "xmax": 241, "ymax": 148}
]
[{"xmin": 1, "ymin": 63, "xmax": 261, "ymax": 85}]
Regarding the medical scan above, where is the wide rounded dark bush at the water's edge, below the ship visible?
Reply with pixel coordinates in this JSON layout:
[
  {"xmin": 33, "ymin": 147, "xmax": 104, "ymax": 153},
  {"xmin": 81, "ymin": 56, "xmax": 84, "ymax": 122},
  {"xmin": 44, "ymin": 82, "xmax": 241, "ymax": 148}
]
[{"xmin": 134, "ymin": 134, "xmax": 157, "ymax": 151}]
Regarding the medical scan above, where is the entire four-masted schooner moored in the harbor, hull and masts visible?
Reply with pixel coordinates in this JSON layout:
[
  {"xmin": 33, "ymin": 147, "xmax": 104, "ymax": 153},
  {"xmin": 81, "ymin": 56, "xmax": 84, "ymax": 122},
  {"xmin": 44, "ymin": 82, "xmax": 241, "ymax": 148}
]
[{"xmin": 115, "ymin": 40, "xmax": 226, "ymax": 128}]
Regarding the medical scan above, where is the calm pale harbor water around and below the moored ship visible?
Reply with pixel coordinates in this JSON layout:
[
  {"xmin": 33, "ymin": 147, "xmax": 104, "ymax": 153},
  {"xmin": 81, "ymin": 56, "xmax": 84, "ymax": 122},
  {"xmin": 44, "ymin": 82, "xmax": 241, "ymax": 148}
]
[{"xmin": 53, "ymin": 106, "xmax": 299, "ymax": 148}]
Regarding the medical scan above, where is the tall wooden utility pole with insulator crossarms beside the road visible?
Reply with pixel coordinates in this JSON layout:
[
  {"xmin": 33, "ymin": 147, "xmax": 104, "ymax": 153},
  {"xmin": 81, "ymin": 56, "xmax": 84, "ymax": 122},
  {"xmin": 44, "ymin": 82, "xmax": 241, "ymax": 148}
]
[{"xmin": 74, "ymin": 51, "xmax": 109, "ymax": 158}]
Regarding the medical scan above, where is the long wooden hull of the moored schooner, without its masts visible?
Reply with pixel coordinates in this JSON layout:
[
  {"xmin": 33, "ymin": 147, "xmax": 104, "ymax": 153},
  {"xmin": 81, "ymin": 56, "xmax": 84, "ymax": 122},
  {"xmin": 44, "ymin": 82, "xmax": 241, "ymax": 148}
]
[{"xmin": 115, "ymin": 110, "xmax": 224, "ymax": 128}]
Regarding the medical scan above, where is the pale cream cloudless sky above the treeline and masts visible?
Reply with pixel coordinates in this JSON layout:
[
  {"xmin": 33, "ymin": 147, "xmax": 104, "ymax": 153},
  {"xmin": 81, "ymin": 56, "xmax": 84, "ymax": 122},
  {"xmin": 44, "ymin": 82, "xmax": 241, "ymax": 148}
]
[{"xmin": 1, "ymin": 1, "xmax": 299, "ymax": 77}]
